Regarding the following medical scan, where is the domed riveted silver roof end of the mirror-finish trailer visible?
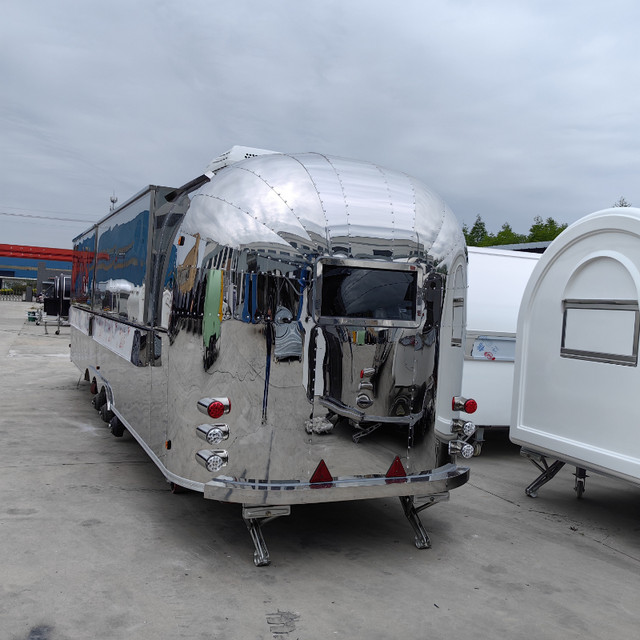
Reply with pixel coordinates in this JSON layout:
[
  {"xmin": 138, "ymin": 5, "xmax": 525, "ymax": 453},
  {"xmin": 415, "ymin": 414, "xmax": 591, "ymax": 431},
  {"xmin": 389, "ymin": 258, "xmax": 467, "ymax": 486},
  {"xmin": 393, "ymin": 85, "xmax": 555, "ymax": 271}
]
[{"xmin": 182, "ymin": 153, "xmax": 464, "ymax": 264}]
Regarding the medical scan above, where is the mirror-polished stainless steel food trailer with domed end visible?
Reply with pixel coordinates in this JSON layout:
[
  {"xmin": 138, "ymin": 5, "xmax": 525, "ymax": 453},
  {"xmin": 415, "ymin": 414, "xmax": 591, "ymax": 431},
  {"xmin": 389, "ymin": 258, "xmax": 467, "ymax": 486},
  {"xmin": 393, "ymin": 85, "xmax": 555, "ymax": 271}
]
[{"xmin": 71, "ymin": 147, "xmax": 475, "ymax": 565}]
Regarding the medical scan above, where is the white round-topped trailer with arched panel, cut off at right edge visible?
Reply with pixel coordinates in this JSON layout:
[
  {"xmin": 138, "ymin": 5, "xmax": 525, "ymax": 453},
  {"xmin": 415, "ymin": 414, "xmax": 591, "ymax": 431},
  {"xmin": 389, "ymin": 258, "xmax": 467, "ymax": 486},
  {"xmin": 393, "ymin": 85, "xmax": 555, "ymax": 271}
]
[{"xmin": 510, "ymin": 207, "xmax": 640, "ymax": 497}]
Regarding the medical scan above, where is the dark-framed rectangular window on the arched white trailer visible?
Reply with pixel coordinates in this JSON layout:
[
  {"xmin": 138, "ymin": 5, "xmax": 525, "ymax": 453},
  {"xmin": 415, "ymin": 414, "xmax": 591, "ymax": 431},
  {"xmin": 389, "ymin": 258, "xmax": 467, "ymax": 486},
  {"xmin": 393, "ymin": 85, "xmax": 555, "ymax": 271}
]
[{"xmin": 560, "ymin": 300, "xmax": 639, "ymax": 366}]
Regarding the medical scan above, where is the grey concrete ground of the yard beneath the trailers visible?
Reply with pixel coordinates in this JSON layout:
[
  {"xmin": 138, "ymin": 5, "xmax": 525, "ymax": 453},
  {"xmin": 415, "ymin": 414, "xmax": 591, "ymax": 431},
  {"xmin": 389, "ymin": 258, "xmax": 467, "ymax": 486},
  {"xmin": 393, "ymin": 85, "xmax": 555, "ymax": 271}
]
[{"xmin": 0, "ymin": 302, "xmax": 640, "ymax": 640}]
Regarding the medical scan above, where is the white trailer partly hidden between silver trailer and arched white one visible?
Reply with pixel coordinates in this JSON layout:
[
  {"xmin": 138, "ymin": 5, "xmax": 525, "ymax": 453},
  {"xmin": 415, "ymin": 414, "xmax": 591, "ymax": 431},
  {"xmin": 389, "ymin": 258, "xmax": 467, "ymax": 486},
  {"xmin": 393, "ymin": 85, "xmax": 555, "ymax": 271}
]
[{"xmin": 462, "ymin": 247, "xmax": 540, "ymax": 453}]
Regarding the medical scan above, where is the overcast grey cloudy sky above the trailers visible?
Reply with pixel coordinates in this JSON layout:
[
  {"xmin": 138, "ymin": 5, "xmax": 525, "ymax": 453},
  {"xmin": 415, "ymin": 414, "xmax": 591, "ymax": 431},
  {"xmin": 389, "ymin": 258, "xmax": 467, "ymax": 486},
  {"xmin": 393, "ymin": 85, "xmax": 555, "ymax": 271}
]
[{"xmin": 0, "ymin": 0, "xmax": 640, "ymax": 248}]
